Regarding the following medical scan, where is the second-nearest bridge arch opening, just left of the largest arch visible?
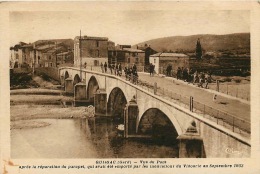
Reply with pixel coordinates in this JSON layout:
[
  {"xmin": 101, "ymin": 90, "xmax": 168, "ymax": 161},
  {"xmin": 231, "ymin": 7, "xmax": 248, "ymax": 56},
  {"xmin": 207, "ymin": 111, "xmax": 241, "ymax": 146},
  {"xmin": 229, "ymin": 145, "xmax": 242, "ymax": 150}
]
[{"xmin": 107, "ymin": 87, "xmax": 127, "ymax": 121}]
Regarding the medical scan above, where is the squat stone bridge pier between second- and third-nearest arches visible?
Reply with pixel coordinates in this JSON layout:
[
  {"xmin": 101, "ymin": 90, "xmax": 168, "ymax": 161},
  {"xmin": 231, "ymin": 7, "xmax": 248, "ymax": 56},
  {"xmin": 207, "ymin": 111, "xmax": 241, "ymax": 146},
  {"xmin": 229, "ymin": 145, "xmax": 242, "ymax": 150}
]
[{"xmin": 94, "ymin": 89, "xmax": 107, "ymax": 116}]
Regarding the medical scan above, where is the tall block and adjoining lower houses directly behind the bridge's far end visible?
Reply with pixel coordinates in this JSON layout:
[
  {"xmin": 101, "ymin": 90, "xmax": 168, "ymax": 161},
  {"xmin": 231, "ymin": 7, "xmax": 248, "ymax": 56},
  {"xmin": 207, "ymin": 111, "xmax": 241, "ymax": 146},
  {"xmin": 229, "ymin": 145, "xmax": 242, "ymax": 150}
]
[{"xmin": 74, "ymin": 36, "xmax": 157, "ymax": 66}]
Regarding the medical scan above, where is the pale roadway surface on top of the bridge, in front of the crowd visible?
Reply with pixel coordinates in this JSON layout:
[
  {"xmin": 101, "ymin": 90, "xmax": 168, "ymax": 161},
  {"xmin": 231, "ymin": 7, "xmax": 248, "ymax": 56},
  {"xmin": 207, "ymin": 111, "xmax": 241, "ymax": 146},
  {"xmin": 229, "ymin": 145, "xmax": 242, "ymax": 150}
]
[{"xmin": 139, "ymin": 73, "xmax": 250, "ymax": 122}]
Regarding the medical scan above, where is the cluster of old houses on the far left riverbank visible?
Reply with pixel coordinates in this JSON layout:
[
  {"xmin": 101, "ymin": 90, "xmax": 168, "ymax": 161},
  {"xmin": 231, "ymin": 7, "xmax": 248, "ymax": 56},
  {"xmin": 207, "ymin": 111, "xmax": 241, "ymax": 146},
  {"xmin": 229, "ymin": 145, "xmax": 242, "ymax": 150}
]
[{"xmin": 10, "ymin": 39, "xmax": 74, "ymax": 68}]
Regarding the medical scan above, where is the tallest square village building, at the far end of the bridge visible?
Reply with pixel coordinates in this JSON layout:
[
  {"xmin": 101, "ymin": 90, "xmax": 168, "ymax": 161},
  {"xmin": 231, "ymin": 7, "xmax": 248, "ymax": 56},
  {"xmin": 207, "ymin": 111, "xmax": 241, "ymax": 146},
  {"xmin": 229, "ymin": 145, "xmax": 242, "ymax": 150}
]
[{"xmin": 74, "ymin": 36, "xmax": 113, "ymax": 67}]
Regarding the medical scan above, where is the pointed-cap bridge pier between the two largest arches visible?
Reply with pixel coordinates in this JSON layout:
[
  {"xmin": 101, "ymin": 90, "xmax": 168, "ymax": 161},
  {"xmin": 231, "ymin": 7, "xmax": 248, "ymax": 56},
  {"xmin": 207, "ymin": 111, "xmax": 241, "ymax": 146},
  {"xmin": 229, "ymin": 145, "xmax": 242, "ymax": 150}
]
[{"xmin": 124, "ymin": 98, "xmax": 139, "ymax": 138}]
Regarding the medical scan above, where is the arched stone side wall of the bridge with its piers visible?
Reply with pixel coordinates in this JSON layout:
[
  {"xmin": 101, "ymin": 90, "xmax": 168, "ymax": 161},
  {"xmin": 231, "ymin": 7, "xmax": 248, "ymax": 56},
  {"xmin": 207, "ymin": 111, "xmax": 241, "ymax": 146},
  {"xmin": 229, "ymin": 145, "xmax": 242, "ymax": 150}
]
[{"xmin": 59, "ymin": 67, "xmax": 251, "ymax": 158}]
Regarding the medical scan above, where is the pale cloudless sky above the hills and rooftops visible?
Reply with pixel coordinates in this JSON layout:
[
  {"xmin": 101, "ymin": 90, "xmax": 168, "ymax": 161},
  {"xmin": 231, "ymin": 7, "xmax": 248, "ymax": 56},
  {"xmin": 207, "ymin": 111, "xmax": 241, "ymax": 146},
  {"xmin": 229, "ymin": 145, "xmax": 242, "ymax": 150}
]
[{"xmin": 9, "ymin": 9, "xmax": 250, "ymax": 45}]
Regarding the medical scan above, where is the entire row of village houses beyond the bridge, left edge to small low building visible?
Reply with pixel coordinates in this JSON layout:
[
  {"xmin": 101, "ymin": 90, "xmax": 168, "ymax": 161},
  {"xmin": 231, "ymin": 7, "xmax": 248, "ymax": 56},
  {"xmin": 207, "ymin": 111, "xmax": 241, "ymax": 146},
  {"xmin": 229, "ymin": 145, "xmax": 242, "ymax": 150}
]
[{"xmin": 10, "ymin": 36, "xmax": 193, "ymax": 75}]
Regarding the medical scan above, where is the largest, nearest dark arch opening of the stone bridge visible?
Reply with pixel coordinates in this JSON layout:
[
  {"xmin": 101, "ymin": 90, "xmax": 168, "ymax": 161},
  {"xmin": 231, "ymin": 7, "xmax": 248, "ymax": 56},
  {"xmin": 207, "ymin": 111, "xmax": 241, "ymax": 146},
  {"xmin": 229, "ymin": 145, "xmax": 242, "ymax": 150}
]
[{"xmin": 138, "ymin": 108, "xmax": 178, "ymax": 143}]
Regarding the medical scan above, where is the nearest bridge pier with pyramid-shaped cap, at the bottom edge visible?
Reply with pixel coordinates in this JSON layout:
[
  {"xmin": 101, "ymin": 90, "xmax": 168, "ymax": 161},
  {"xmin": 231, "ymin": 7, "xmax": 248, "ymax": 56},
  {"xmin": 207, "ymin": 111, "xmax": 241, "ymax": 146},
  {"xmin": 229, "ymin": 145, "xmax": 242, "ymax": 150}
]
[{"xmin": 177, "ymin": 121, "xmax": 206, "ymax": 158}]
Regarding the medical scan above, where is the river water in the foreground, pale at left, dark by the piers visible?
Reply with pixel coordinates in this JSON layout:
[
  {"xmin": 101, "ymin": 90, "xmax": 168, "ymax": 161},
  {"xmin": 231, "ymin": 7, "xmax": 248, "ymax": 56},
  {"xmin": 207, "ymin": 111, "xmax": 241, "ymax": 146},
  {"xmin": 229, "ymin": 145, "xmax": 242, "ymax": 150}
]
[{"xmin": 11, "ymin": 118, "xmax": 178, "ymax": 158}]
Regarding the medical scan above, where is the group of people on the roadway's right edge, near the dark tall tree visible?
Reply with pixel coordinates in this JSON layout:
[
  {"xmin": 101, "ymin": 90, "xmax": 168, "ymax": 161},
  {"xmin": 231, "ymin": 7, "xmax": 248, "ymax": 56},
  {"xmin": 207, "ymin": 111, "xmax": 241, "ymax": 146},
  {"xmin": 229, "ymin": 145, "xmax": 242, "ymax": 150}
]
[{"xmin": 176, "ymin": 67, "xmax": 212, "ymax": 88}]
